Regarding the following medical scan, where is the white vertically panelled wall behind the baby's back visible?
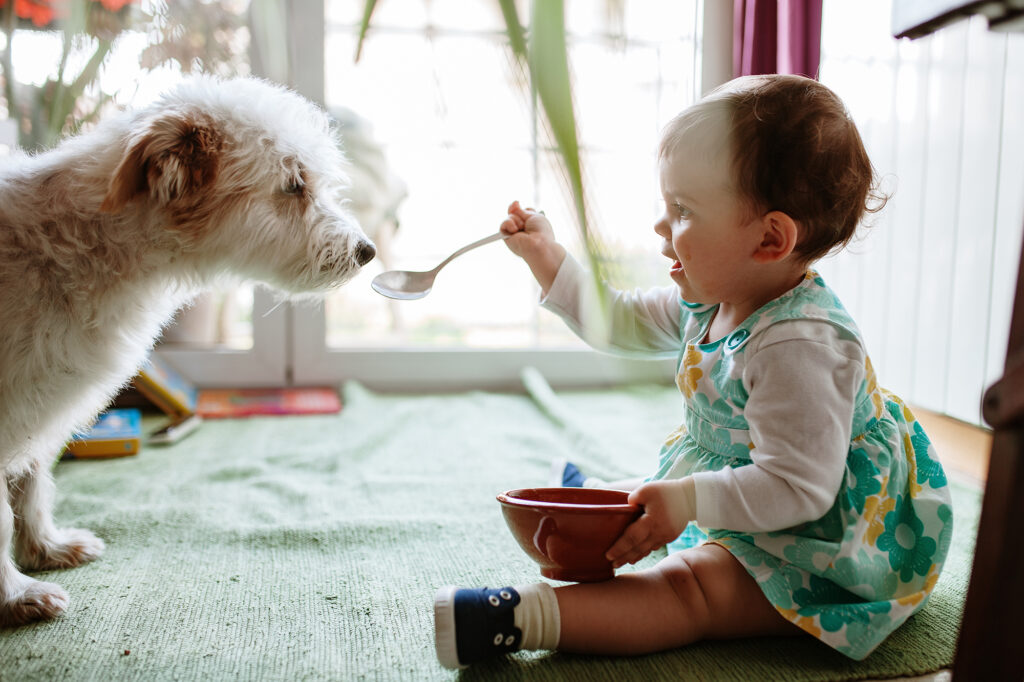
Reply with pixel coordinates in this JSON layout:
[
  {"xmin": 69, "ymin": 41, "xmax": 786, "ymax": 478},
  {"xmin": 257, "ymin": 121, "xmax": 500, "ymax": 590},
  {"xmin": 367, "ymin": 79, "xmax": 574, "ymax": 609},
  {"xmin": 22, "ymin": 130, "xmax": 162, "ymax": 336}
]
[{"xmin": 819, "ymin": 7, "xmax": 1024, "ymax": 423}]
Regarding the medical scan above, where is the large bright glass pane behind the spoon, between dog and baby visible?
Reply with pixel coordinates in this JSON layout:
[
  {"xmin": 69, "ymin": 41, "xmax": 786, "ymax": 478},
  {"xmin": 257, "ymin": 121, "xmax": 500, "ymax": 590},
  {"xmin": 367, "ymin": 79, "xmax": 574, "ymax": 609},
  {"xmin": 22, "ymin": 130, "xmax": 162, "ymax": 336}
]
[{"xmin": 326, "ymin": 0, "xmax": 697, "ymax": 348}]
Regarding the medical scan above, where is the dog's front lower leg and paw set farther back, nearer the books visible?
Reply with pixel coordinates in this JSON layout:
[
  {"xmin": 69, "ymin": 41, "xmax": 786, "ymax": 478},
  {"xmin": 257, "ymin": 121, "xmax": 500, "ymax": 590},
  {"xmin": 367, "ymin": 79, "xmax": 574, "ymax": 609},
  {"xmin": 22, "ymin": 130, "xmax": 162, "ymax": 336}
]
[{"xmin": 10, "ymin": 460, "xmax": 103, "ymax": 570}]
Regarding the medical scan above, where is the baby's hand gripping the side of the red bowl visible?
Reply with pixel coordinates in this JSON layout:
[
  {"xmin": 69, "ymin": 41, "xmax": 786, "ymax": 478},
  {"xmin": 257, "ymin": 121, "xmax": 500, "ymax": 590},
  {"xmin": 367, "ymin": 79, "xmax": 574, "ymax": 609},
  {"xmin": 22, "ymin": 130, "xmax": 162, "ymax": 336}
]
[{"xmin": 605, "ymin": 478, "xmax": 696, "ymax": 568}]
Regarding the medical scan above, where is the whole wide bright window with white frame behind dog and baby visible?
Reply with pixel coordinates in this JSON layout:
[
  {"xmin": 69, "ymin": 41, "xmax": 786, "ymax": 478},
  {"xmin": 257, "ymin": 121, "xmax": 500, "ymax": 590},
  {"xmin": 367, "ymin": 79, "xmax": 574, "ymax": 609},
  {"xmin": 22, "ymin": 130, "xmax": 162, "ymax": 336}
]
[{"xmin": 0, "ymin": 0, "xmax": 707, "ymax": 389}]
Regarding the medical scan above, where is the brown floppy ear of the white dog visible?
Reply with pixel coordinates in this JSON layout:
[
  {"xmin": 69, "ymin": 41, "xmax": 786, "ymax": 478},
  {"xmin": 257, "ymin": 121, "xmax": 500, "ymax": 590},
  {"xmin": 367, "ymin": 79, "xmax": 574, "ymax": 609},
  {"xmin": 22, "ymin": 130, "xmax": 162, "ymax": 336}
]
[{"xmin": 99, "ymin": 113, "xmax": 223, "ymax": 213}]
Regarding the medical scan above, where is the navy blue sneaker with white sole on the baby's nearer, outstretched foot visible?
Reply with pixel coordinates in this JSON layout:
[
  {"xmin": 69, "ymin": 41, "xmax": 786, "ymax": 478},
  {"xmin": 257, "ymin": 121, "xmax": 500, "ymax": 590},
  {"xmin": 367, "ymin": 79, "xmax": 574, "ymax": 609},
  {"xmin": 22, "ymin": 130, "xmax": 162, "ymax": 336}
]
[{"xmin": 434, "ymin": 586, "xmax": 522, "ymax": 670}]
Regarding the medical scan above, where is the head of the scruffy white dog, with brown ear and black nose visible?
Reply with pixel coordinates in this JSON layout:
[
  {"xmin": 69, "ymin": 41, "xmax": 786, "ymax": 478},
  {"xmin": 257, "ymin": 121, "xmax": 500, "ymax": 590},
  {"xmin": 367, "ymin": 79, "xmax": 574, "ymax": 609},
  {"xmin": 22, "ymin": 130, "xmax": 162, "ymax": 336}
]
[{"xmin": 100, "ymin": 78, "xmax": 375, "ymax": 293}]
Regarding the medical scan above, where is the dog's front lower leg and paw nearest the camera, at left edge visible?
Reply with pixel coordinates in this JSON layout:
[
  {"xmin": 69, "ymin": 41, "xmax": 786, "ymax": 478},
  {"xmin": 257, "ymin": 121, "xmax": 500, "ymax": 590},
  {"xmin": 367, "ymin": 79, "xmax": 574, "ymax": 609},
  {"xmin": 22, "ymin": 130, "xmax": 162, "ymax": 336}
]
[{"xmin": 0, "ymin": 473, "xmax": 68, "ymax": 627}]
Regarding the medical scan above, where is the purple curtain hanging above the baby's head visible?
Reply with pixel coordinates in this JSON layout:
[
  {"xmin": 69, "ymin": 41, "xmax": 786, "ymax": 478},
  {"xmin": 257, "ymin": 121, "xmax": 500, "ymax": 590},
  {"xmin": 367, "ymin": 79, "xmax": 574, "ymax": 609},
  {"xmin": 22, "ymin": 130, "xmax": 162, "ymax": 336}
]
[{"xmin": 732, "ymin": 0, "xmax": 821, "ymax": 78}]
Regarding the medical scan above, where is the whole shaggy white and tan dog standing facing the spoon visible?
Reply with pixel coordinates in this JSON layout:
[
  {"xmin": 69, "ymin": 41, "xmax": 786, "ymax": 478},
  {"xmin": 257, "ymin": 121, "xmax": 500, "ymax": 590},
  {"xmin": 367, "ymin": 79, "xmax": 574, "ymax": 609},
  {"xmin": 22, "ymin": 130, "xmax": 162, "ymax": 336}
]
[{"xmin": 0, "ymin": 78, "xmax": 374, "ymax": 626}]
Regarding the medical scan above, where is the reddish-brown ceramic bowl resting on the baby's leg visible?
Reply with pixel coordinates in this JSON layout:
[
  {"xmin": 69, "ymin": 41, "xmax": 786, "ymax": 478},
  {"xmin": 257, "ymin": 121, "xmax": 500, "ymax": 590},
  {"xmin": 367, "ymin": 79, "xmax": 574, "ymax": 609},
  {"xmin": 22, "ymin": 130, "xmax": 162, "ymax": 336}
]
[{"xmin": 498, "ymin": 487, "xmax": 642, "ymax": 583}]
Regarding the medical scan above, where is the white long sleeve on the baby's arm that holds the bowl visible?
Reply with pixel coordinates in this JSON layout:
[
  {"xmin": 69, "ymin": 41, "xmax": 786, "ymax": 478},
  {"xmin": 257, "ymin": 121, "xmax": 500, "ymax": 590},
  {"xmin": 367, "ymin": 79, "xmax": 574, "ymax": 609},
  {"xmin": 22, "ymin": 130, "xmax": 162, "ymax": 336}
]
[{"xmin": 693, "ymin": 321, "xmax": 865, "ymax": 531}]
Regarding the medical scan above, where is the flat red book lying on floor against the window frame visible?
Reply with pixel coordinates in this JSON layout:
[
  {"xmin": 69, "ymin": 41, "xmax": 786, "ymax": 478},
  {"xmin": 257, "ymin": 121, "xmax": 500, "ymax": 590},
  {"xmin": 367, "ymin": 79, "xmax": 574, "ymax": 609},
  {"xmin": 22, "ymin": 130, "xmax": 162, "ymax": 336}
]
[{"xmin": 196, "ymin": 388, "xmax": 341, "ymax": 419}]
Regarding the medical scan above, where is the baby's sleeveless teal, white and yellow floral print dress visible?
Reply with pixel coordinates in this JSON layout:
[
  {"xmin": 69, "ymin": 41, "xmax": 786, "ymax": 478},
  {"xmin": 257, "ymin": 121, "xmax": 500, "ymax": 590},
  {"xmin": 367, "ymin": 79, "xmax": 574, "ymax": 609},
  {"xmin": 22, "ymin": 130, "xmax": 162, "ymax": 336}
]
[{"xmin": 651, "ymin": 271, "xmax": 952, "ymax": 660}]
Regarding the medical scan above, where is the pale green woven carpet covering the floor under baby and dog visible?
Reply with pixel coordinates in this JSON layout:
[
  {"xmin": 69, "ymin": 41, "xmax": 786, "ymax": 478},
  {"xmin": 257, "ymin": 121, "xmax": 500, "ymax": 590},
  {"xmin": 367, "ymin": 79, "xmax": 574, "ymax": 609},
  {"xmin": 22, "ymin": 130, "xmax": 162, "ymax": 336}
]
[{"xmin": 0, "ymin": 375, "xmax": 979, "ymax": 682}]
